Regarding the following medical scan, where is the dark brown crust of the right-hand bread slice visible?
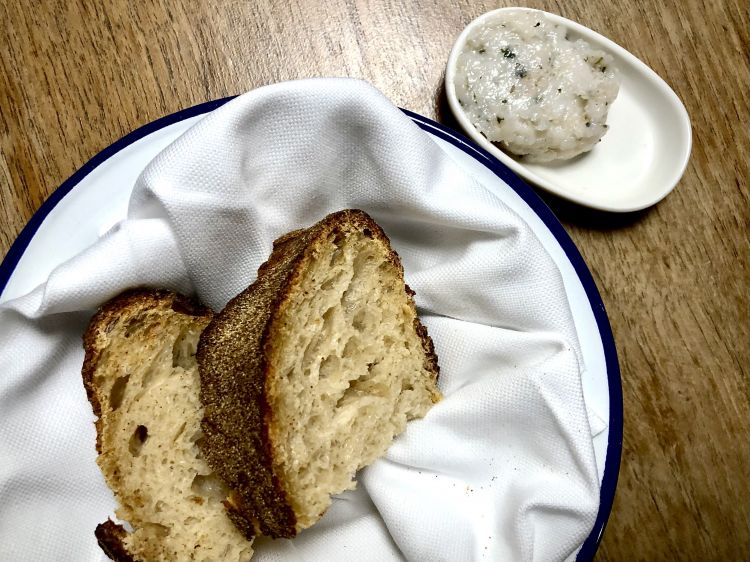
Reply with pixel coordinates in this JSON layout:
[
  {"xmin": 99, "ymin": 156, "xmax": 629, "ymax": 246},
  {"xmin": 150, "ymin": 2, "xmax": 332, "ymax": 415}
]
[{"xmin": 197, "ymin": 210, "xmax": 438, "ymax": 538}]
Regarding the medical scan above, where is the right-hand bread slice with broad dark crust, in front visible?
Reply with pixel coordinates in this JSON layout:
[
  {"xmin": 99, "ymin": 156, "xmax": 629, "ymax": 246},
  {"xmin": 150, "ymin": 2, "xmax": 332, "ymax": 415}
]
[{"xmin": 198, "ymin": 210, "xmax": 440, "ymax": 537}]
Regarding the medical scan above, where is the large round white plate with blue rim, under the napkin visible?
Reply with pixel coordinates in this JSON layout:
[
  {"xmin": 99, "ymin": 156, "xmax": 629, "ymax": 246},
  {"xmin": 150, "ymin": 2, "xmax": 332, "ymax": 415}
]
[{"xmin": 0, "ymin": 98, "xmax": 622, "ymax": 560}]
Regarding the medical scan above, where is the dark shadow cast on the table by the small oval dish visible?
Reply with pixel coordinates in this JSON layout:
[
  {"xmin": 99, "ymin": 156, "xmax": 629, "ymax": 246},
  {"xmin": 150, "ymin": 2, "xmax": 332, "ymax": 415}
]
[{"xmin": 435, "ymin": 76, "xmax": 653, "ymax": 231}]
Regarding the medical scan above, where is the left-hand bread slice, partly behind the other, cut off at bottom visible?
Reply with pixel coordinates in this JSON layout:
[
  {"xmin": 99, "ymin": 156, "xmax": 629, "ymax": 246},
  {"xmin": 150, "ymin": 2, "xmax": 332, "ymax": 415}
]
[{"xmin": 83, "ymin": 290, "xmax": 252, "ymax": 562}]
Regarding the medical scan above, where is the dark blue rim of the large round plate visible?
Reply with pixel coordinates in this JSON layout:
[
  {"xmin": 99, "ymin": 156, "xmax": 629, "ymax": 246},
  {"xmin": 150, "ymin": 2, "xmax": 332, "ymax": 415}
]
[{"xmin": 0, "ymin": 96, "xmax": 623, "ymax": 561}]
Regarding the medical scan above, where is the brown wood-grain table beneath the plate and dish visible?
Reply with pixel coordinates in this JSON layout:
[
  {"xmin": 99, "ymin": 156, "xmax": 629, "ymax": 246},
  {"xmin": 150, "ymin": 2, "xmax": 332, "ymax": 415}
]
[{"xmin": 0, "ymin": 0, "xmax": 750, "ymax": 561}]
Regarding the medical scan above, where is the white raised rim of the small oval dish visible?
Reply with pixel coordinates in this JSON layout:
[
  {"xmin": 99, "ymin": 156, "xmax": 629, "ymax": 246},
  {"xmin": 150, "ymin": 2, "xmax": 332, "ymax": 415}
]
[{"xmin": 444, "ymin": 6, "xmax": 693, "ymax": 213}]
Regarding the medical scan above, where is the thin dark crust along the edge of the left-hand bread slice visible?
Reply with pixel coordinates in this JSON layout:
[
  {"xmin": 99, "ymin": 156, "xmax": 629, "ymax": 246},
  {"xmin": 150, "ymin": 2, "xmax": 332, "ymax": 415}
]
[{"xmin": 81, "ymin": 288, "xmax": 213, "ymax": 562}]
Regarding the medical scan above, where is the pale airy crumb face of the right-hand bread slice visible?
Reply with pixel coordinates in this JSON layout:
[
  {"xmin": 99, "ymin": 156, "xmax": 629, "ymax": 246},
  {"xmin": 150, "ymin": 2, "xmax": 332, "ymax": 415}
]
[{"xmin": 267, "ymin": 229, "xmax": 439, "ymax": 530}]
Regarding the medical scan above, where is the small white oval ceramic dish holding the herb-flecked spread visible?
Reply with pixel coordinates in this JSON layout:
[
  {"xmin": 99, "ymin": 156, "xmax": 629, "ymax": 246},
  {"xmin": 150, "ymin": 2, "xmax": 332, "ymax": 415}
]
[{"xmin": 445, "ymin": 8, "xmax": 692, "ymax": 212}]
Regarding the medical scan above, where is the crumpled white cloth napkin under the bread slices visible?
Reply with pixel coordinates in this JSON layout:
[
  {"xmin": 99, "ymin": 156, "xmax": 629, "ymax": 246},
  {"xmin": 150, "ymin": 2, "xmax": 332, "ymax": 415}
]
[{"xmin": 0, "ymin": 79, "xmax": 599, "ymax": 562}]
